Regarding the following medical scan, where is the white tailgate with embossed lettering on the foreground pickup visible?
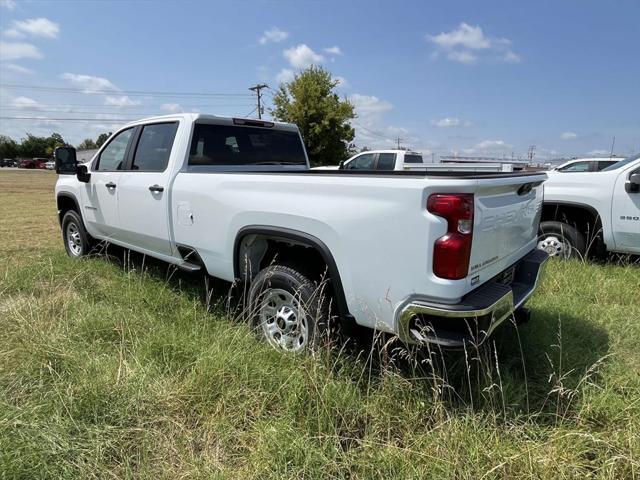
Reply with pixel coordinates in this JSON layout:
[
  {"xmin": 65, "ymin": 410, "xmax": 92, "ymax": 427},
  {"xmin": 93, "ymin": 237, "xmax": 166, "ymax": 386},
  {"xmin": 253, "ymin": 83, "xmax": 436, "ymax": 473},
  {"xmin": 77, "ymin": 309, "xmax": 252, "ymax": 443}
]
[{"xmin": 467, "ymin": 173, "xmax": 546, "ymax": 288}]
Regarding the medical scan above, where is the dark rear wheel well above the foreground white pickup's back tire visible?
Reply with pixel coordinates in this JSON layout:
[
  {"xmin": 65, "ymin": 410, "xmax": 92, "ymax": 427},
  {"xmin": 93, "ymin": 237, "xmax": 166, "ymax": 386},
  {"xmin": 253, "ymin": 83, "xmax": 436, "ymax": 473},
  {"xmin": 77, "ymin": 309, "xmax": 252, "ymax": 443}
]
[{"xmin": 234, "ymin": 228, "xmax": 353, "ymax": 321}]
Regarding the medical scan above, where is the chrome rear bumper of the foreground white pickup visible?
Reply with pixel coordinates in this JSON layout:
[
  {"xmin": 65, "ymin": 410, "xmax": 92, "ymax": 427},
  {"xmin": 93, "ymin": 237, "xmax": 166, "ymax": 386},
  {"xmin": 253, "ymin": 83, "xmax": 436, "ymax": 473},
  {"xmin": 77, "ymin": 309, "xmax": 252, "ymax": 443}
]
[{"xmin": 398, "ymin": 249, "xmax": 549, "ymax": 348}]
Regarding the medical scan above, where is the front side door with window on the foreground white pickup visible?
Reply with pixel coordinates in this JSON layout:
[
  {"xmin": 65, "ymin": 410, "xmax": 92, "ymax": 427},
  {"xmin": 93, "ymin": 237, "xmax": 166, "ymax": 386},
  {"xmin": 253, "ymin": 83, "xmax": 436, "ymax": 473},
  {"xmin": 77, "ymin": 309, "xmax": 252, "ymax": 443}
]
[{"xmin": 83, "ymin": 128, "xmax": 133, "ymax": 240}]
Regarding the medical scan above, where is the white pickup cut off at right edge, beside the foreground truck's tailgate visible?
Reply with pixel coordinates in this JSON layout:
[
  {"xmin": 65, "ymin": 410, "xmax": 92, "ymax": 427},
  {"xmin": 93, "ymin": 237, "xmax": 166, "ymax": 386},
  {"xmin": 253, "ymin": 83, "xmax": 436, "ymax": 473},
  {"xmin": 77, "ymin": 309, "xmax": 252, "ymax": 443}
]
[{"xmin": 538, "ymin": 155, "xmax": 640, "ymax": 258}]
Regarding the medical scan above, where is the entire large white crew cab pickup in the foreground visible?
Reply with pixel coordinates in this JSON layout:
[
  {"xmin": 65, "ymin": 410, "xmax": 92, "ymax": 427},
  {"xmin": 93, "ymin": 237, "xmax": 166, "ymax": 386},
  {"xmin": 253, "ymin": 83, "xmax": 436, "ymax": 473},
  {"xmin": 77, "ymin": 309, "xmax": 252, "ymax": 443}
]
[{"xmin": 55, "ymin": 114, "xmax": 547, "ymax": 351}]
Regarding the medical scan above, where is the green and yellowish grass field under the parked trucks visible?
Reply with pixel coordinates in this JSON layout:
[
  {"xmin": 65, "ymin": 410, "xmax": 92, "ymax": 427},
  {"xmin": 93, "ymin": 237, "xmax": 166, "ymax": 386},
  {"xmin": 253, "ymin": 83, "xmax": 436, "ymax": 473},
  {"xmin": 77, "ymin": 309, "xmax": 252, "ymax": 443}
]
[{"xmin": 0, "ymin": 170, "xmax": 640, "ymax": 479}]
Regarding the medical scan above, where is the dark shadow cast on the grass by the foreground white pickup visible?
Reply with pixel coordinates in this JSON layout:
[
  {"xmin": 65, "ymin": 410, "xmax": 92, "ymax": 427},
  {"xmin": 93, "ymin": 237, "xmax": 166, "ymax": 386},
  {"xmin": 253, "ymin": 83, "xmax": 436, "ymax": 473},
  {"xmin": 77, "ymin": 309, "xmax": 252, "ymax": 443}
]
[{"xmin": 98, "ymin": 245, "xmax": 609, "ymax": 424}]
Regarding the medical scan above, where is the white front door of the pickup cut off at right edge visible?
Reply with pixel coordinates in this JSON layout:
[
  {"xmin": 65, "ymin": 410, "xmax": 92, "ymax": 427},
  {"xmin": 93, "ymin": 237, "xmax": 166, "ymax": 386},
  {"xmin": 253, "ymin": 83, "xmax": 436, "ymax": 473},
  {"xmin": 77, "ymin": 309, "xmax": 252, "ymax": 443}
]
[{"xmin": 611, "ymin": 169, "xmax": 640, "ymax": 253}]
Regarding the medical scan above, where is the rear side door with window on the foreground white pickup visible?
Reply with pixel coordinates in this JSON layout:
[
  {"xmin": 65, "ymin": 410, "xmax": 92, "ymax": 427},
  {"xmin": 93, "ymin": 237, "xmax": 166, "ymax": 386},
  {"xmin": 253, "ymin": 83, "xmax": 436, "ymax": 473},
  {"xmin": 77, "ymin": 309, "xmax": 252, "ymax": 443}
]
[{"xmin": 118, "ymin": 121, "xmax": 178, "ymax": 255}]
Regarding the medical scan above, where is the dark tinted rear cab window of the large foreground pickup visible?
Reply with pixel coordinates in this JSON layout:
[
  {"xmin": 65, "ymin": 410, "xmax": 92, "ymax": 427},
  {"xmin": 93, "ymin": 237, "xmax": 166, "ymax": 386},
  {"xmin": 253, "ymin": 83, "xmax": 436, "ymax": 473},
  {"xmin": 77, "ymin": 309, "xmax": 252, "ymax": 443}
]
[{"xmin": 189, "ymin": 123, "xmax": 307, "ymax": 167}]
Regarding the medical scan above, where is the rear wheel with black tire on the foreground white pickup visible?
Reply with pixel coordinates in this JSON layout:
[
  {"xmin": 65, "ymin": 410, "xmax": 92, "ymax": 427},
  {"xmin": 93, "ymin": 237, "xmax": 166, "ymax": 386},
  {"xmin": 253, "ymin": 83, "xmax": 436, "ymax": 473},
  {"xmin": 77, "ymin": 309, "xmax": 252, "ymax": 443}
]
[{"xmin": 248, "ymin": 265, "xmax": 330, "ymax": 353}]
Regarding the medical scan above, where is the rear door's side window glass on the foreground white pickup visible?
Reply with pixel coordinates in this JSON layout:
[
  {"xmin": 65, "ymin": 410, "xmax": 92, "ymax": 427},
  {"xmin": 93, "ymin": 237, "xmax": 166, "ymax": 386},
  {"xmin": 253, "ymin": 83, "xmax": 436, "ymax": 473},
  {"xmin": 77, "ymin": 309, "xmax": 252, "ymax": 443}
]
[{"xmin": 131, "ymin": 122, "xmax": 178, "ymax": 172}]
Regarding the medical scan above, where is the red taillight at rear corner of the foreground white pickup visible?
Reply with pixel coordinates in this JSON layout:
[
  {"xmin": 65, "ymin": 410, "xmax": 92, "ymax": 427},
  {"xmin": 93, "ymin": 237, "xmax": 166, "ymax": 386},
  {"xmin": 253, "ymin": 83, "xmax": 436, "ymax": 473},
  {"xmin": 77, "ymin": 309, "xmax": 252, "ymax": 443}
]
[{"xmin": 427, "ymin": 193, "xmax": 473, "ymax": 280}]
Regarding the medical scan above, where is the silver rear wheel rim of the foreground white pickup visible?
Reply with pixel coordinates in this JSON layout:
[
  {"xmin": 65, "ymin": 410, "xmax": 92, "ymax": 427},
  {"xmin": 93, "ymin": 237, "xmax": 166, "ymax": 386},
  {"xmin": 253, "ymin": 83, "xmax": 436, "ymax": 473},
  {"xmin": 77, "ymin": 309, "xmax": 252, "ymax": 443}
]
[{"xmin": 258, "ymin": 288, "xmax": 308, "ymax": 352}]
